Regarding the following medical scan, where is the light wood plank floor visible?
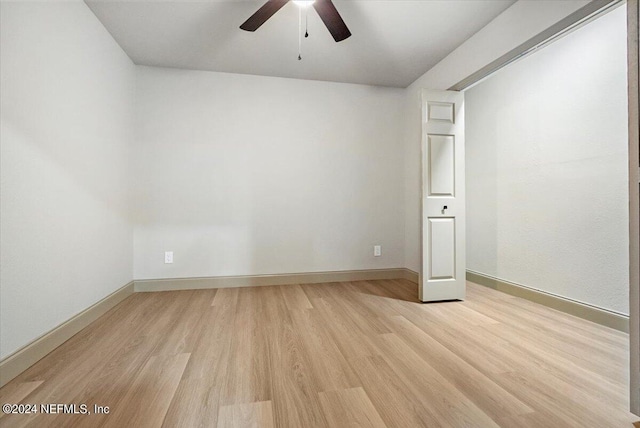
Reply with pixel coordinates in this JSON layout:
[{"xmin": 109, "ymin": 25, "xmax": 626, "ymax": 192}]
[{"xmin": 0, "ymin": 280, "xmax": 638, "ymax": 428}]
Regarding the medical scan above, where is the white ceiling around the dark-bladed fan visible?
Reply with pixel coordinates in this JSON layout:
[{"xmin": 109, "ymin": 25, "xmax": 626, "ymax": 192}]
[{"xmin": 85, "ymin": 0, "xmax": 515, "ymax": 87}]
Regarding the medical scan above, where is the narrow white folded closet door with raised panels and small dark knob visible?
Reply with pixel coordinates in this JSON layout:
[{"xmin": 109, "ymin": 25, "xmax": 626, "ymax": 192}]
[{"xmin": 420, "ymin": 90, "xmax": 466, "ymax": 302}]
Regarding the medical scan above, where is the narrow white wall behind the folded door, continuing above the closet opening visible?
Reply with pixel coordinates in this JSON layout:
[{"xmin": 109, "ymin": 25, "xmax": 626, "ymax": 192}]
[{"xmin": 403, "ymin": 0, "xmax": 589, "ymax": 271}]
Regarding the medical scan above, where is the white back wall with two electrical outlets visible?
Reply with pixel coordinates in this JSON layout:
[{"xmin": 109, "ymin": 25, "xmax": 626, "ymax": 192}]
[{"xmin": 134, "ymin": 67, "xmax": 404, "ymax": 279}]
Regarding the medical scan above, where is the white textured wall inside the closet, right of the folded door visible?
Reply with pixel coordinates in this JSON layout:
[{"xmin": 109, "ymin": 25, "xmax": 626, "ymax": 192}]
[{"xmin": 466, "ymin": 7, "xmax": 629, "ymax": 314}]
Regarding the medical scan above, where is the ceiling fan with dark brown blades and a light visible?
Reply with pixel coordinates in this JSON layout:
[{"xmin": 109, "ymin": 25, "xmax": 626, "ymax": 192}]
[{"xmin": 240, "ymin": 0, "xmax": 351, "ymax": 42}]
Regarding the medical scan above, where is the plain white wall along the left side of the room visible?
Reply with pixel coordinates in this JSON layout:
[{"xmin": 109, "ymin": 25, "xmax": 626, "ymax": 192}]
[{"xmin": 0, "ymin": 1, "xmax": 135, "ymax": 357}]
